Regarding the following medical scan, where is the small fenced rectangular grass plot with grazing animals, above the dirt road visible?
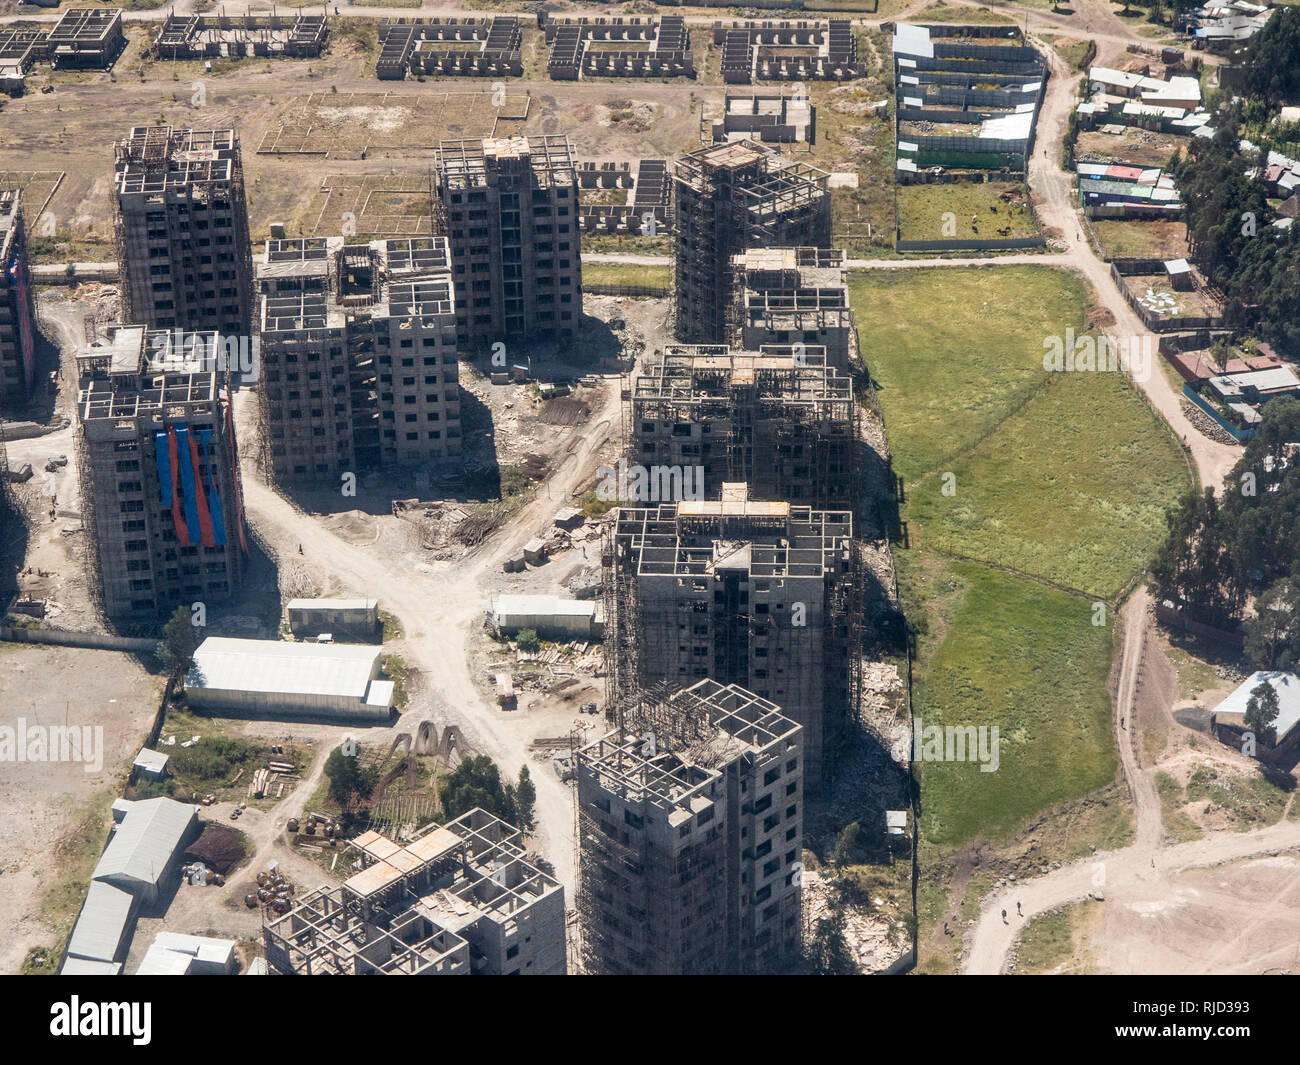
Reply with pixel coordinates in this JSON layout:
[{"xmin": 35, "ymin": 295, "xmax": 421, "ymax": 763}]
[{"xmin": 898, "ymin": 181, "xmax": 1037, "ymax": 241}]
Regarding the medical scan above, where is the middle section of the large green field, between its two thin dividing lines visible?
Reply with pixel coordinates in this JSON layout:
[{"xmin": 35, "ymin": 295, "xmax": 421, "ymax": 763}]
[{"xmin": 909, "ymin": 373, "xmax": 1188, "ymax": 601}]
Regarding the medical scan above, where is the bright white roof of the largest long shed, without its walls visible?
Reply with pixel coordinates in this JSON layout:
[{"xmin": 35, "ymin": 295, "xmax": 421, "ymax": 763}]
[{"xmin": 186, "ymin": 636, "xmax": 380, "ymax": 700}]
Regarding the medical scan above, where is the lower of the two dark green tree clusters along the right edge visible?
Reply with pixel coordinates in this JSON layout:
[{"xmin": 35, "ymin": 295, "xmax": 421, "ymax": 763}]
[{"xmin": 1152, "ymin": 398, "xmax": 1300, "ymax": 670}]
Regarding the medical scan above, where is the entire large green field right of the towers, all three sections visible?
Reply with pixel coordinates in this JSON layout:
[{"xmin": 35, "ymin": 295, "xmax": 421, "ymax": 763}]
[{"xmin": 850, "ymin": 267, "xmax": 1188, "ymax": 847}]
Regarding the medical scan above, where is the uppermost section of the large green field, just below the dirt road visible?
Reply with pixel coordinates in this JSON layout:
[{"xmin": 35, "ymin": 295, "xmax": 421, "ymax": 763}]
[{"xmin": 849, "ymin": 267, "xmax": 1087, "ymax": 482}]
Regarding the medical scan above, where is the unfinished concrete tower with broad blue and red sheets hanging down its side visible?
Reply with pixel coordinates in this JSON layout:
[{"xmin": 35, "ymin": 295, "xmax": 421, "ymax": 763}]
[{"xmin": 77, "ymin": 325, "xmax": 248, "ymax": 618}]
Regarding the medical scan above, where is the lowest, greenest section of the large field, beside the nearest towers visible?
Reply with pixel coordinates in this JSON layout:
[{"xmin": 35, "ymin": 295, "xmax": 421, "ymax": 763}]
[{"xmin": 900, "ymin": 553, "xmax": 1117, "ymax": 845}]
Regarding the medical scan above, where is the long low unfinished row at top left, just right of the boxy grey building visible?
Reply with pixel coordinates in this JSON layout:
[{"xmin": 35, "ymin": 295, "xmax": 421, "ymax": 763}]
[{"xmin": 153, "ymin": 12, "xmax": 329, "ymax": 60}]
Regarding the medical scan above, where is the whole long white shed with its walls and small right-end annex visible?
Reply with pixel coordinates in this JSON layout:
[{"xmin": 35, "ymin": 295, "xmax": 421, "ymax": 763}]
[{"xmin": 186, "ymin": 636, "xmax": 394, "ymax": 722}]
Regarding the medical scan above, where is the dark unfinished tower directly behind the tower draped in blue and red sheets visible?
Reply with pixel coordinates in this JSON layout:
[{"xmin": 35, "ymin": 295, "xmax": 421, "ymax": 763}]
[{"xmin": 114, "ymin": 126, "xmax": 252, "ymax": 337}]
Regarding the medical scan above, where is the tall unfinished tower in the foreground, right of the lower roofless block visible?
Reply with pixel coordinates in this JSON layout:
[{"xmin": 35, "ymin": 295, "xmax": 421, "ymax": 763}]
[{"xmin": 576, "ymin": 680, "xmax": 803, "ymax": 974}]
